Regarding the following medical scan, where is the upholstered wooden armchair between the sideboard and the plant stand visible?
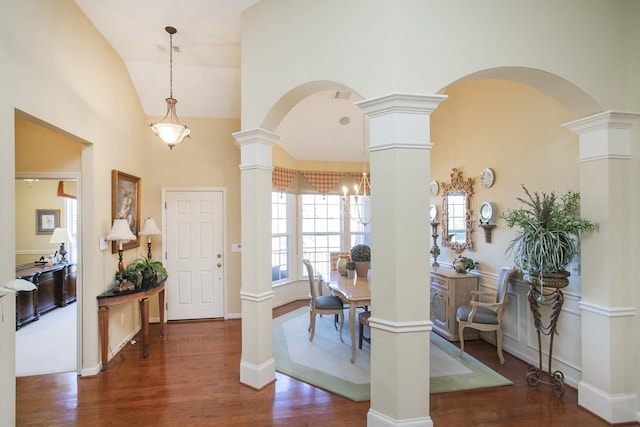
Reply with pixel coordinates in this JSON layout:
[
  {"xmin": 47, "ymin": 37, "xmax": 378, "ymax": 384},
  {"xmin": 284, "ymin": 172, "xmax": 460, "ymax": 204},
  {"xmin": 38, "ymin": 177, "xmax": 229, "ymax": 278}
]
[{"xmin": 456, "ymin": 267, "xmax": 515, "ymax": 364}]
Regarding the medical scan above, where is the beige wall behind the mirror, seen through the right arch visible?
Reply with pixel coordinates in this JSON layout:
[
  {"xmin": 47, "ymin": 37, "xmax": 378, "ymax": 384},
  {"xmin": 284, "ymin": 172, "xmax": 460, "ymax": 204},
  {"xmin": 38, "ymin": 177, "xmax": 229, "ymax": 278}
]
[{"xmin": 431, "ymin": 80, "xmax": 579, "ymax": 280}]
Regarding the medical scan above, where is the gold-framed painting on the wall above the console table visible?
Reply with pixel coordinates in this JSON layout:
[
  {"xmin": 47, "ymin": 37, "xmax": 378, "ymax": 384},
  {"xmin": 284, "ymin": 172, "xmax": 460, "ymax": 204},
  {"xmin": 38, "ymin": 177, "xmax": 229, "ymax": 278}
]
[{"xmin": 111, "ymin": 169, "xmax": 141, "ymax": 254}]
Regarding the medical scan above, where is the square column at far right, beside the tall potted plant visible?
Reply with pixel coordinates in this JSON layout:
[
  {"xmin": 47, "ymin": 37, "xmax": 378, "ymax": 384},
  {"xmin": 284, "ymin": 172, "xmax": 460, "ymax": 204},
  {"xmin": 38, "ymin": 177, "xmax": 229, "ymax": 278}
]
[{"xmin": 563, "ymin": 111, "xmax": 640, "ymax": 423}]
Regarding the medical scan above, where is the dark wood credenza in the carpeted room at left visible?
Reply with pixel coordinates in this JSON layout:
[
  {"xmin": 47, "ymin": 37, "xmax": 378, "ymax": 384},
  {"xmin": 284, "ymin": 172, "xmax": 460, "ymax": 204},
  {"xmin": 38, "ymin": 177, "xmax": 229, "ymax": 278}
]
[{"xmin": 16, "ymin": 264, "xmax": 76, "ymax": 329}]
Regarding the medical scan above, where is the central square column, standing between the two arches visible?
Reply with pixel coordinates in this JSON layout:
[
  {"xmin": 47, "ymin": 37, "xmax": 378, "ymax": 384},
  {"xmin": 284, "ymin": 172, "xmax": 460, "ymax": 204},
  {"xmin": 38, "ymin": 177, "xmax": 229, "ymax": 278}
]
[{"xmin": 357, "ymin": 93, "xmax": 446, "ymax": 426}]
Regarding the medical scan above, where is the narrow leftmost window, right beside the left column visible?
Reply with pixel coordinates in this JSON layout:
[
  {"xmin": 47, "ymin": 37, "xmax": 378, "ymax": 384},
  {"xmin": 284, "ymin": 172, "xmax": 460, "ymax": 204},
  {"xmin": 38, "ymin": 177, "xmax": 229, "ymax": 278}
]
[{"xmin": 271, "ymin": 192, "xmax": 292, "ymax": 282}]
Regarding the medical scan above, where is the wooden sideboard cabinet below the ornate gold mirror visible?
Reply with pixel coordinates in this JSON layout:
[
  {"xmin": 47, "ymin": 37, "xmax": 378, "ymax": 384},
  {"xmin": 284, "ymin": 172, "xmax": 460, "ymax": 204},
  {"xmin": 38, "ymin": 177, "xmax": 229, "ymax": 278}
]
[{"xmin": 429, "ymin": 267, "xmax": 478, "ymax": 341}]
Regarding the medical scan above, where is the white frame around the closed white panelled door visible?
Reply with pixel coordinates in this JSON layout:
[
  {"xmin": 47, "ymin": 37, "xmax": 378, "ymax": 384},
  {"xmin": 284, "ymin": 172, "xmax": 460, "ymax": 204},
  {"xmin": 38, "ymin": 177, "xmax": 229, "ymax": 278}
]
[{"xmin": 161, "ymin": 187, "xmax": 229, "ymax": 321}]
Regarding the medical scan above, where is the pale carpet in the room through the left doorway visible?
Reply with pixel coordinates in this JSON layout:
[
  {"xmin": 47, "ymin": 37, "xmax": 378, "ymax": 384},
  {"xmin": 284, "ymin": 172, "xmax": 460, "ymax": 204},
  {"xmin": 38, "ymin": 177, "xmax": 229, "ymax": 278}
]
[{"xmin": 16, "ymin": 303, "xmax": 77, "ymax": 377}]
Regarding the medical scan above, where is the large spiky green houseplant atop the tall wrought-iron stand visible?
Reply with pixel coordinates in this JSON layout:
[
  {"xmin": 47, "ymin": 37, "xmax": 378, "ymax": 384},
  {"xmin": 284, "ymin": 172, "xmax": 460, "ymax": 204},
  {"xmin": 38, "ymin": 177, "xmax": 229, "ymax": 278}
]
[{"xmin": 501, "ymin": 185, "xmax": 597, "ymax": 287}]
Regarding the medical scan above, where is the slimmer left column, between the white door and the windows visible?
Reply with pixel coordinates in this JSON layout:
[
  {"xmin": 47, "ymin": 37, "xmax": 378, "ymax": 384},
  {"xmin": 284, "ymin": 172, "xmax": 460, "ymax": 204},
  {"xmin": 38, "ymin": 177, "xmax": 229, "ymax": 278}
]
[{"xmin": 233, "ymin": 129, "xmax": 280, "ymax": 389}]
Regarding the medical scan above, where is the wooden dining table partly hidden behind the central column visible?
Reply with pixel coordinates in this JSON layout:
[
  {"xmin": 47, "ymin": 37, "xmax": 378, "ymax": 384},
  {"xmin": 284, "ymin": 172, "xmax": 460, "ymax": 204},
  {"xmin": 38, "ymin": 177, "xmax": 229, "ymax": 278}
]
[{"xmin": 328, "ymin": 271, "xmax": 371, "ymax": 363}]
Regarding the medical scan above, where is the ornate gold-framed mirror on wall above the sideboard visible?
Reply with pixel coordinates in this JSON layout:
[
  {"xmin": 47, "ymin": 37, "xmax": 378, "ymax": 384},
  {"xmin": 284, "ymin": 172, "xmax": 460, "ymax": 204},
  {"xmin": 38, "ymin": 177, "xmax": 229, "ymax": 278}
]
[{"xmin": 441, "ymin": 168, "xmax": 473, "ymax": 254}]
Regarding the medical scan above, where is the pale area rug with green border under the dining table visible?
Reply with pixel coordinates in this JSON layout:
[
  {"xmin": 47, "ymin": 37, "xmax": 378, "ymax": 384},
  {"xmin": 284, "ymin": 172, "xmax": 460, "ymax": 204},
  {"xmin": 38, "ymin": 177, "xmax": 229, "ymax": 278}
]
[{"xmin": 273, "ymin": 307, "xmax": 512, "ymax": 402}]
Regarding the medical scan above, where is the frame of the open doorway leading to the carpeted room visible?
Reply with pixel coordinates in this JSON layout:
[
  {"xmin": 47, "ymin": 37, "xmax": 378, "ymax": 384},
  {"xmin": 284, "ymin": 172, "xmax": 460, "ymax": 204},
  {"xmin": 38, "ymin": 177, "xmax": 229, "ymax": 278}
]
[{"xmin": 14, "ymin": 172, "xmax": 83, "ymax": 375}]
